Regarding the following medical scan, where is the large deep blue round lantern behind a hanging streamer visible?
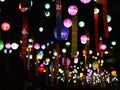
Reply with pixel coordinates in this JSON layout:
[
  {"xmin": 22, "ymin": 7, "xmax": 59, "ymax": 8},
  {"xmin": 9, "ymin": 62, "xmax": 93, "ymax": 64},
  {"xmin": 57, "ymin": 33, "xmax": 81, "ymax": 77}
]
[{"xmin": 54, "ymin": 25, "xmax": 69, "ymax": 41}]
